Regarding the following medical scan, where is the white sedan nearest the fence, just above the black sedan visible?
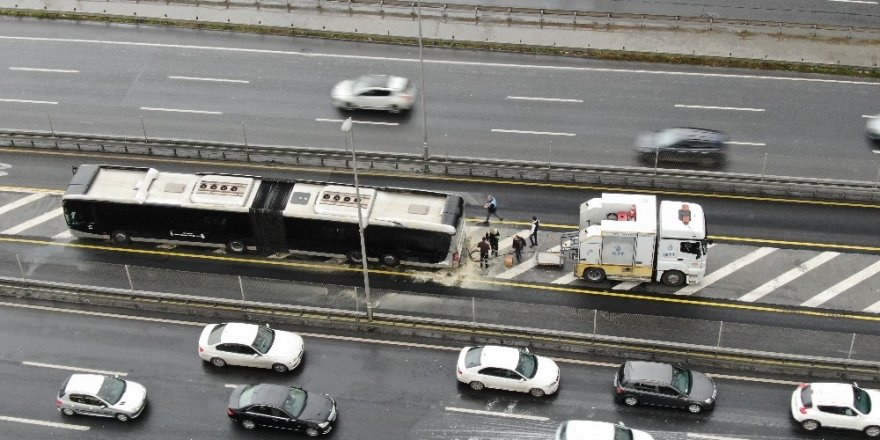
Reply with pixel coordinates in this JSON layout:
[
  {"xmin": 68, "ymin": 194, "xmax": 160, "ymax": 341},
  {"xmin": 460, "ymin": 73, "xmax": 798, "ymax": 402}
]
[{"xmin": 199, "ymin": 322, "xmax": 305, "ymax": 373}]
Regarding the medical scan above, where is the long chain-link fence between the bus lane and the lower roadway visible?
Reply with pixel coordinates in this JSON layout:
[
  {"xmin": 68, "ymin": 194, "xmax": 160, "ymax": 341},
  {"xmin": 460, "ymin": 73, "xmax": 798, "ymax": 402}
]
[{"xmin": 6, "ymin": 254, "xmax": 880, "ymax": 362}]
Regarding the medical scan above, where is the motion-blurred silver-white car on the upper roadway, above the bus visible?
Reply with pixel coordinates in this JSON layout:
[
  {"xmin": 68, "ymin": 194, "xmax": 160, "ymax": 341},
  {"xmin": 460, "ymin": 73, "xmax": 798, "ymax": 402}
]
[{"xmin": 330, "ymin": 75, "xmax": 416, "ymax": 113}]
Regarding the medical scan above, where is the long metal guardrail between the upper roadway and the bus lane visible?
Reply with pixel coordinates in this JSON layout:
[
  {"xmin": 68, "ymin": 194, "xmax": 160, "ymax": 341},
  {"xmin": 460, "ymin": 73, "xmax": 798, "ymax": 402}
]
[{"xmin": 0, "ymin": 129, "xmax": 880, "ymax": 203}]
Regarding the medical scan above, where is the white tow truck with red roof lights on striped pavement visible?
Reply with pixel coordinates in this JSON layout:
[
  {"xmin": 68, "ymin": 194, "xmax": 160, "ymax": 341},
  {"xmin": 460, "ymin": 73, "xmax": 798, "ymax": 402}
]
[{"xmin": 567, "ymin": 194, "xmax": 708, "ymax": 286}]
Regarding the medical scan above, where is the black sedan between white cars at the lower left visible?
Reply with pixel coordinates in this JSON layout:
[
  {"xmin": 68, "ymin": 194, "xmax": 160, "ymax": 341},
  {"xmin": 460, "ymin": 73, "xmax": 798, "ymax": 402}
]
[{"xmin": 226, "ymin": 383, "xmax": 338, "ymax": 437}]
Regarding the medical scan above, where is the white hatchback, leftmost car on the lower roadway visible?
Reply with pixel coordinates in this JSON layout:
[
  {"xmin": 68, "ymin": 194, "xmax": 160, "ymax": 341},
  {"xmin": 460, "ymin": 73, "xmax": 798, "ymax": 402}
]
[{"xmin": 55, "ymin": 374, "xmax": 147, "ymax": 422}]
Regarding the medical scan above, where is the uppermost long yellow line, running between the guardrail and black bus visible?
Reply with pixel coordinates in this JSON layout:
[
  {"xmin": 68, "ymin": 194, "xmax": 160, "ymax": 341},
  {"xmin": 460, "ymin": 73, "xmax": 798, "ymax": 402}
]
[{"xmin": 6, "ymin": 147, "xmax": 880, "ymax": 209}]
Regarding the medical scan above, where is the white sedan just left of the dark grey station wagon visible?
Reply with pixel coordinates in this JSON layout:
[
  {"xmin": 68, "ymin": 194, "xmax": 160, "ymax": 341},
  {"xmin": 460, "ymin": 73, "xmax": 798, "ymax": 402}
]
[{"xmin": 456, "ymin": 345, "xmax": 559, "ymax": 397}]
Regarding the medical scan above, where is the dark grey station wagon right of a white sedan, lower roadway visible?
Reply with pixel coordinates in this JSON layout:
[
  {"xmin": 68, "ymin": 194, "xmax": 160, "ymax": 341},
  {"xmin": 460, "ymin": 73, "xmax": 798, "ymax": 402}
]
[{"xmin": 614, "ymin": 361, "xmax": 717, "ymax": 413}]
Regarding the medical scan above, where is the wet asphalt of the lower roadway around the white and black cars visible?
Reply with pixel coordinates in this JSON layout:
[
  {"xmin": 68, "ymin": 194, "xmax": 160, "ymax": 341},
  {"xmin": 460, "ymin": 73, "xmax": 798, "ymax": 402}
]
[{"xmin": 0, "ymin": 305, "xmax": 869, "ymax": 440}]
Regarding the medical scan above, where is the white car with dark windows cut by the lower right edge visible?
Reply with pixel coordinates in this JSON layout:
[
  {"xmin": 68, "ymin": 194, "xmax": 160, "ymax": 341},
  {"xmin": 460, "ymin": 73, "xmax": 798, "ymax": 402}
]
[{"xmin": 791, "ymin": 383, "xmax": 880, "ymax": 437}]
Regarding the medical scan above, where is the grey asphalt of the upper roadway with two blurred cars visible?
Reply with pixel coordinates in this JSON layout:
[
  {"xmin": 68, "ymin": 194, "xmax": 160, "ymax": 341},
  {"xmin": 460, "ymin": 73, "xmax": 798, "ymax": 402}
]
[{"xmin": 0, "ymin": 18, "xmax": 880, "ymax": 181}]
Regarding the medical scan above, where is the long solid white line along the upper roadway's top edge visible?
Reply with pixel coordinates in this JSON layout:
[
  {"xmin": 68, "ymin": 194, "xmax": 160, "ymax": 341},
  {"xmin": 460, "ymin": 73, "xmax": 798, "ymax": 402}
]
[{"xmin": 0, "ymin": 35, "xmax": 880, "ymax": 87}]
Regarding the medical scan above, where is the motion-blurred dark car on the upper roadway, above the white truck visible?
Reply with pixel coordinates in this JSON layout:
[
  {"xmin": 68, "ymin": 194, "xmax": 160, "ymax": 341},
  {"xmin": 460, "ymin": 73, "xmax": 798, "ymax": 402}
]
[{"xmin": 636, "ymin": 128, "xmax": 727, "ymax": 167}]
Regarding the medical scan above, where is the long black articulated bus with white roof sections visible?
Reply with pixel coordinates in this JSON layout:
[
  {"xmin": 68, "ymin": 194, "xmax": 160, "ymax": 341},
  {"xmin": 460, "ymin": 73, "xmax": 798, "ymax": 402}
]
[{"xmin": 62, "ymin": 165, "xmax": 466, "ymax": 267}]
